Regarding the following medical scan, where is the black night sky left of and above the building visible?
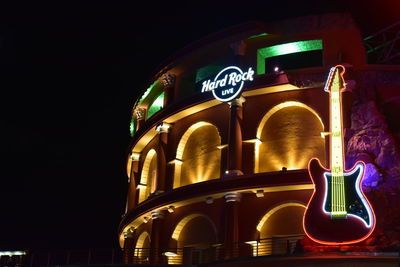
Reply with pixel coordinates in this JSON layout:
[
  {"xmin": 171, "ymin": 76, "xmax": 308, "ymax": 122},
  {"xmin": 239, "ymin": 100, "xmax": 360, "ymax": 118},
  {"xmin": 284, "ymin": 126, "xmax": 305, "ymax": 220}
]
[{"xmin": 0, "ymin": 0, "xmax": 399, "ymax": 250}]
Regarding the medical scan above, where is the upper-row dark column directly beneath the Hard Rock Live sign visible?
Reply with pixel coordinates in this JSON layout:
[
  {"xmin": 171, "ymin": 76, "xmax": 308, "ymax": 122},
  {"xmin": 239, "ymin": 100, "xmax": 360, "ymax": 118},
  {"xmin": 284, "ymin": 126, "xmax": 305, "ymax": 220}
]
[{"xmin": 225, "ymin": 97, "xmax": 245, "ymax": 176}]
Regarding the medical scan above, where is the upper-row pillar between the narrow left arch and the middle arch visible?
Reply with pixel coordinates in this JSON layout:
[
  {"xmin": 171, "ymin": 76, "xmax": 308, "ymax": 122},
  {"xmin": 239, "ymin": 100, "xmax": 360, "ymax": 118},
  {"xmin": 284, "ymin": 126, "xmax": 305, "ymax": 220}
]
[{"xmin": 155, "ymin": 122, "xmax": 171, "ymax": 194}]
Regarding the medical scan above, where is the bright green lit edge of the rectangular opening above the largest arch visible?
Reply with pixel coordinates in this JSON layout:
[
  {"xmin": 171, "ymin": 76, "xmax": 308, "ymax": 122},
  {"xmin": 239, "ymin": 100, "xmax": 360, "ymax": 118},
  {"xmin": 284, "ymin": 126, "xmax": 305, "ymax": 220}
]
[{"xmin": 257, "ymin": 40, "xmax": 322, "ymax": 75}]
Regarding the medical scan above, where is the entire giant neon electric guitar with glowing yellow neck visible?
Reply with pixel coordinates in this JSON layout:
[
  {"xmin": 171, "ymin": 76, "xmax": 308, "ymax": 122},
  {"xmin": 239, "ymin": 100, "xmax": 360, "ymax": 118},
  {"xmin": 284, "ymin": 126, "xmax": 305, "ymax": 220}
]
[{"xmin": 303, "ymin": 65, "xmax": 375, "ymax": 245}]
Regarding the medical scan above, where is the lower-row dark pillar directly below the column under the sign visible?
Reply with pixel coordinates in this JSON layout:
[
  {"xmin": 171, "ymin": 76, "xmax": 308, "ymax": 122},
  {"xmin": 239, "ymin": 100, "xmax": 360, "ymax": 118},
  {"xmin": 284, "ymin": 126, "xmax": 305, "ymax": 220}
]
[{"xmin": 224, "ymin": 192, "xmax": 241, "ymax": 259}]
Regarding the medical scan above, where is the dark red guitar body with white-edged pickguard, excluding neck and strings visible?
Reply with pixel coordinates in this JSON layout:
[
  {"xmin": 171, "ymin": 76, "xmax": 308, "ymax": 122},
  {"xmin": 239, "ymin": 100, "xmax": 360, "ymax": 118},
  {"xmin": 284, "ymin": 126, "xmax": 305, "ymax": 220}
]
[{"xmin": 303, "ymin": 159, "xmax": 375, "ymax": 245}]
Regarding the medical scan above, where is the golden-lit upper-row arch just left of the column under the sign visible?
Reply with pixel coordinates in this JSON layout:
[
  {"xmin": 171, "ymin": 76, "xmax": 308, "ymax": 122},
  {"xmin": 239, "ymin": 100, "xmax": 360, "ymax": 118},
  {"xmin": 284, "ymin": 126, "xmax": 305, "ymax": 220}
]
[{"xmin": 174, "ymin": 121, "xmax": 221, "ymax": 188}]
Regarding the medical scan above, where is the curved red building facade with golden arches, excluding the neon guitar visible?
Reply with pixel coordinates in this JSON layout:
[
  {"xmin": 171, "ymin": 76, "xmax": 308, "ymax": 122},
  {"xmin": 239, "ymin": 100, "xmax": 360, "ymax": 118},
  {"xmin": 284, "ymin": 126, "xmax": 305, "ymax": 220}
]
[{"xmin": 119, "ymin": 14, "xmax": 399, "ymax": 264}]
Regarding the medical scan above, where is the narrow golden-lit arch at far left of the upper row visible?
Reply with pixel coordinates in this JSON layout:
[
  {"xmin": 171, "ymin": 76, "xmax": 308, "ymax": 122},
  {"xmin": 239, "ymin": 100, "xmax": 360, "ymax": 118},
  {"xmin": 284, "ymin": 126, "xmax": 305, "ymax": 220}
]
[{"xmin": 138, "ymin": 149, "xmax": 157, "ymax": 203}]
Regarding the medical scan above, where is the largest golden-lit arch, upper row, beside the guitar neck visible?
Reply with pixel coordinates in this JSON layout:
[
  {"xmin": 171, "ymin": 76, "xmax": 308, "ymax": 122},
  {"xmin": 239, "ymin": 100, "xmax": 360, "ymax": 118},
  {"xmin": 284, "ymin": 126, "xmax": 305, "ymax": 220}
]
[{"xmin": 254, "ymin": 101, "xmax": 325, "ymax": 173}]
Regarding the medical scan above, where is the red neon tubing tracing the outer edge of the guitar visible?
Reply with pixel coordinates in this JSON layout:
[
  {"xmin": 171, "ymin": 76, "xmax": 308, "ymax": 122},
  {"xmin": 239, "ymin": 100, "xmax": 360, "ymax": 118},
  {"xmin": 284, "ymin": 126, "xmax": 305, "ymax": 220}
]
[{"xmin": 303, "ymin": 65, "xmax": 376, "ymax": 245}]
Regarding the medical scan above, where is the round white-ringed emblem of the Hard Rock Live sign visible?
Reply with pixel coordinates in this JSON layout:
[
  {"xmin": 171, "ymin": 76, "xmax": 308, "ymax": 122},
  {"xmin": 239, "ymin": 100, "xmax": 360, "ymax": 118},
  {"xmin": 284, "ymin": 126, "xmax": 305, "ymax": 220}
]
[{"xmin": 212, "ymin": 66, "xmax": 246, "ymax": 102}]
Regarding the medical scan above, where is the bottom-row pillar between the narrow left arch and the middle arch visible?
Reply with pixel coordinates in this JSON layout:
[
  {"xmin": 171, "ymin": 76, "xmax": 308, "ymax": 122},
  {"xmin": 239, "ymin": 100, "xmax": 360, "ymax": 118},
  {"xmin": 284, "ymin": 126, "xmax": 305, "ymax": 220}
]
[{"xmin": 150, "ymin": 210, "xmax": 165, "ymax": 264}]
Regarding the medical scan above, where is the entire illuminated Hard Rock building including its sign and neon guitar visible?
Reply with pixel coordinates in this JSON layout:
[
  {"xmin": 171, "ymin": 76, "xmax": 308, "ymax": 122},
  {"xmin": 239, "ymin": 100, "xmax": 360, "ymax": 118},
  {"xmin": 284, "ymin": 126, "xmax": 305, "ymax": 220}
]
[{"xmin": 118, "ymin": 14, "xmax": 400, "ymax": 266}]
